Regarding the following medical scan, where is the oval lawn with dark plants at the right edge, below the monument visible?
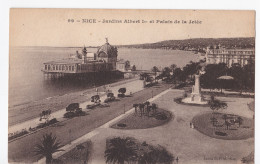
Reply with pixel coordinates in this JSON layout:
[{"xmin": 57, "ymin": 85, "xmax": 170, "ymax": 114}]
[{"xmin": 192, "ymin": 113, "xmax": 254, "ymax": 140}]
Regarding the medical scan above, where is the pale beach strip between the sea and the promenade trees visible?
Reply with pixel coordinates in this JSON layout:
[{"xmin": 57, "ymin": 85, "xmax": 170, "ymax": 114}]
[{"xmin": 8, "ymin": 77, "xmax": 139, "ymax": 127}]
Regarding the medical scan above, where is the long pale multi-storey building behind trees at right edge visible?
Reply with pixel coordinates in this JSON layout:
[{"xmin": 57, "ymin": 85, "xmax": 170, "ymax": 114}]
[{"xmin": 205, "ymin": 45, "xmax": 255, "ymax": 67}]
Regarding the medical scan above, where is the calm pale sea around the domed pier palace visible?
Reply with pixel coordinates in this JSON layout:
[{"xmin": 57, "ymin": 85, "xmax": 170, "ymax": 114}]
[{"xmin": 9, "ymin": 47, "xmax": 199, "ymax": 107}]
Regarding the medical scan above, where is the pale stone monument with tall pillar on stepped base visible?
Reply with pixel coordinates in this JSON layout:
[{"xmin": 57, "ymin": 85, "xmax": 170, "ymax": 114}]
[{"xmin": 182, "ymin": 74, "xmax": 208, "ymax": 104}]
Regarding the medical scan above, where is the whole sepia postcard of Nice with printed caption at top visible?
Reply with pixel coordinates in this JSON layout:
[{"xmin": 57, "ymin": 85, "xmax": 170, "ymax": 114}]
[{"xmin": 8, "ymin": 8, "xmax": 255, "ymax": 164}]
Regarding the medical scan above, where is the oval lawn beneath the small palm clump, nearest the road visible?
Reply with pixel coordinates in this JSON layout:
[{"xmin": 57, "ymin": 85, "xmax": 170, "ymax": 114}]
[{"xmin": 111, "ymin": 108, "xmax": 173, "ymax": 129}]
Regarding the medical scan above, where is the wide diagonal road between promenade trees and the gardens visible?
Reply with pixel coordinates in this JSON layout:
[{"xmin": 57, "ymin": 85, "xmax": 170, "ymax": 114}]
[{"xmin": 8, "ymin": 84, "xmax": 171, "ymax": 163}]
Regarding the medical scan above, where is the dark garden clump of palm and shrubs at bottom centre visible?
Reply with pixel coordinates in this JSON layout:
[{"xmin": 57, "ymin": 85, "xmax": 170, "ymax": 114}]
[{"xmin": 105, "ymin": 137, "xmax": 175, "ymax": 164}]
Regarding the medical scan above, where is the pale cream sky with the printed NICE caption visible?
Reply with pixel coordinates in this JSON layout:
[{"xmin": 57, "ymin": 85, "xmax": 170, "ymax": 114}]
[{"xmin": 9, "ymin": 9, "xmax": 255, "ymax": 47}]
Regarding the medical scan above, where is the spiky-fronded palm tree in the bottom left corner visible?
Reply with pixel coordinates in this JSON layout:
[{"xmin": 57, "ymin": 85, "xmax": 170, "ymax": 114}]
[{"xmin": 34, "ymin": 133, "xmax": 64, "ymax": 164}]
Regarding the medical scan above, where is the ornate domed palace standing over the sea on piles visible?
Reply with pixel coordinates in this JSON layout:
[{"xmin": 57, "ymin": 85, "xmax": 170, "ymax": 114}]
[{"xmin": 42, "ymin": 40, "xmax": 117, "ymax": 74}]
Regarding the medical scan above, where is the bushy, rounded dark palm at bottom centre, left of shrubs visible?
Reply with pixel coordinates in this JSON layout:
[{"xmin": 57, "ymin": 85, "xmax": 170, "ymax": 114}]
[{"xmin": 105, "ymin": 137, "xmax": 137, "ymax": 164}]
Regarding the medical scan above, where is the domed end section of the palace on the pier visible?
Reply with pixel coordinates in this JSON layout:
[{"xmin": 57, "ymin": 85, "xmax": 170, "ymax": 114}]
[{"xmin": 97, "ymin": 38, "xmax": 117, "ymax": 70}]
